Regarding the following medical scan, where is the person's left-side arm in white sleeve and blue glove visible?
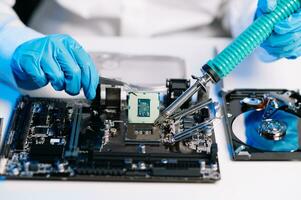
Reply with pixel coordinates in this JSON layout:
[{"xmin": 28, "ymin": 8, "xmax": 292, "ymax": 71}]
[{"xmin": 0, "ymin": 1, "xmax": 99, "ymax": 99}]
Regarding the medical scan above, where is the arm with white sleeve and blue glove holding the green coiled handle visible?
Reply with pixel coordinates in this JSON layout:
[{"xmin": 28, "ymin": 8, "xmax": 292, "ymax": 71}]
[{"xmin": 219, "ymin": 0, "xmax": 301, "ymax": 62}]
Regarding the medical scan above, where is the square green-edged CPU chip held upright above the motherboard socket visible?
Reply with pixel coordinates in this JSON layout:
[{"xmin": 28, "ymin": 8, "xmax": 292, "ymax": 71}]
[{"xmin": 128, "ymin": 92, "xmax": 160, "ymax": 123}]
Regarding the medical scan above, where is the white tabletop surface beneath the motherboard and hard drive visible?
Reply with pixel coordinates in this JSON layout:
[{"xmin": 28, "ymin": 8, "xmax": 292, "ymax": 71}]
[{"xmin": 0, "ymin": 38, "xmax": 301, "ymax": 200}]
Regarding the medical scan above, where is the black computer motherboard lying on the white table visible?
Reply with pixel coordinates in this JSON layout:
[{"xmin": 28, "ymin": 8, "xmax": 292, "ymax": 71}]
[{"xmin": 0, "ymin": 79, "xmax": 220, "ymax": 182}]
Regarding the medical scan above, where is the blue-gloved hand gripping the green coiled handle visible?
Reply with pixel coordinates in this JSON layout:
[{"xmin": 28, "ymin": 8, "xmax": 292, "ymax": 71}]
[{"xmin": 256, "ymin": 0, "xmax": 301, "ymax": 61}]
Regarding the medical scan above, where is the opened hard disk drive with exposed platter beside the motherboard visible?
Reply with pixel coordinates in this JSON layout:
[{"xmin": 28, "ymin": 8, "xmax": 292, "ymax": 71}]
[{"xmin": 223, "ymin": 89, "xmax": 301, "ymax": 160}]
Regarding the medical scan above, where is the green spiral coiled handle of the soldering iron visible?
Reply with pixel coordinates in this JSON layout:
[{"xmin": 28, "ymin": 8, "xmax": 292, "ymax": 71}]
[{"xmin": 205, "ymin": 0, "xmax": 301, "ymax": 79}]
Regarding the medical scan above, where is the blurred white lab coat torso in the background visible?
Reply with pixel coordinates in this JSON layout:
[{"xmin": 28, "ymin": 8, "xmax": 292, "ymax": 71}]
[{"xmin": 30, "ymin": 0, "xmax": 257, "ymax": 37}]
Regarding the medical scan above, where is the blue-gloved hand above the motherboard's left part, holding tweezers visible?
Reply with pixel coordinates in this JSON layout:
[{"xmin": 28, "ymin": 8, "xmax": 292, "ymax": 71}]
[{"xmin": 11, "ymin": 34, "xmax": 99, "ymax": 99}]
